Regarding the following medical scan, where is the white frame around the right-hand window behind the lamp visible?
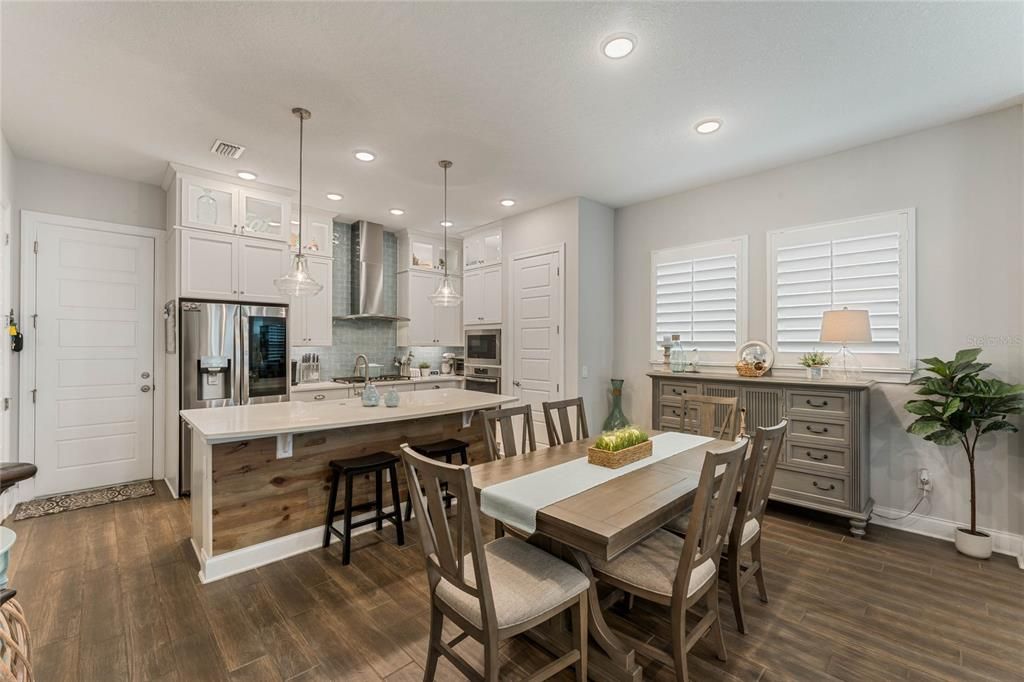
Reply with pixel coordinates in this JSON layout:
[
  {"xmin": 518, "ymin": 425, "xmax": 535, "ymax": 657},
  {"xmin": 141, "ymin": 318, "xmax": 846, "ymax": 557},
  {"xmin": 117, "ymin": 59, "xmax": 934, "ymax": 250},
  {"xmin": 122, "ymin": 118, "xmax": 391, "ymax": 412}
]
[{"xmin": 765, "ymin": 208, "xmax": 918, "ymax": 381}]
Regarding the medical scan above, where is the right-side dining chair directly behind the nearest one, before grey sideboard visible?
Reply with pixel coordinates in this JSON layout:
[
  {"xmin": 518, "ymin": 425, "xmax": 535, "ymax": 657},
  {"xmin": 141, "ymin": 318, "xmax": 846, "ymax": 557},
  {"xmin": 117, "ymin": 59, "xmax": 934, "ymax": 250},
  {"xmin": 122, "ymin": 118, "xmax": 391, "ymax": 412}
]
[{"xmin": 664, "ymin": 419, "xmax": 788, "ymax": 634}]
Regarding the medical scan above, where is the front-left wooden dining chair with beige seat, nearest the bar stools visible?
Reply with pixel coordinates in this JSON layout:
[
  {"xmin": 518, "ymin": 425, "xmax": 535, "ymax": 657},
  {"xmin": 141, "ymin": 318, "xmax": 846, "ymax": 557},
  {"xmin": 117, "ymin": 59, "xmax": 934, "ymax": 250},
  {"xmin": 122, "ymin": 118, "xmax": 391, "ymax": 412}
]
[{"xmin": 401, "ymin": 443, "xmax": 590, "ymax": 682}]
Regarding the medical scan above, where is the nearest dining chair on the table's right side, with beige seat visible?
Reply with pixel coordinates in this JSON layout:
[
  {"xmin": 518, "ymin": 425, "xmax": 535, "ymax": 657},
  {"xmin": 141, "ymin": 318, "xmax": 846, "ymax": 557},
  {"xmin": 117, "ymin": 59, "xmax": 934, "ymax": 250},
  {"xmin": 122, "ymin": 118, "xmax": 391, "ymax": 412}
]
[{"xmin": 591, "ymin": 438, "xmax": 749, "ymax": 681}]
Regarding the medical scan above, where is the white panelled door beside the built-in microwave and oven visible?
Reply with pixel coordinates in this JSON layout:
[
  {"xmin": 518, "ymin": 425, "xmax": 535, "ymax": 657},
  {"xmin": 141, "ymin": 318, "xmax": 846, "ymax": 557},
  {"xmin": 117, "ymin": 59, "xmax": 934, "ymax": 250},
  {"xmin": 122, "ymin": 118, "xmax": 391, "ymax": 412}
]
[{"xmin": 512, "ymin": 250, "xmax": 564, "ymax": 444}]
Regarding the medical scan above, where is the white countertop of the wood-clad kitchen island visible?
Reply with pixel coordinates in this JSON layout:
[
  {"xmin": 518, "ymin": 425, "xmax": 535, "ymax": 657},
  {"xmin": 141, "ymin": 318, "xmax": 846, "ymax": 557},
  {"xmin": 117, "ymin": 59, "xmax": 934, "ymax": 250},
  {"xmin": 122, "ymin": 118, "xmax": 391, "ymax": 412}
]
[{"xmin": 181, "ymin": 388, "xmax": 516, "ymax": 444}]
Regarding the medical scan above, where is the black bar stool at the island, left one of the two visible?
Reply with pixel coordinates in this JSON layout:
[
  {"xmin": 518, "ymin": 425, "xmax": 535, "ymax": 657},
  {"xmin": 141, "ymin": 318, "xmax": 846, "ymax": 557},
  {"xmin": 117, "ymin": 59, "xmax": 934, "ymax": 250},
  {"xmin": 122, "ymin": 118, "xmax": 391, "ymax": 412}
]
[{"xmin": 324, "ymin": 453, "xmax": 406, "ymax": 565}]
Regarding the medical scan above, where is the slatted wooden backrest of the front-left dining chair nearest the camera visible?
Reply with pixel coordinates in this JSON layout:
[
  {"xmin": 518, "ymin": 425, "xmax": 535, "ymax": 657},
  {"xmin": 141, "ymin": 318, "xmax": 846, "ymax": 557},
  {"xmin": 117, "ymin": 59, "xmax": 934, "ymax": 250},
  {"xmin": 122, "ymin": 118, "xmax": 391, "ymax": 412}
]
[{"xmin": 401, "ymin": 443, "xmax": 497, "ymax": 629}]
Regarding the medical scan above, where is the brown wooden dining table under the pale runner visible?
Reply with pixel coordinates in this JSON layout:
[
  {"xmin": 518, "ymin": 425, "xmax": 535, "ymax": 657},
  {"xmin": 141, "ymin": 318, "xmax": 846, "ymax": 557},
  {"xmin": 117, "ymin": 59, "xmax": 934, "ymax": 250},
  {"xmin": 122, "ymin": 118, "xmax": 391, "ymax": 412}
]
[{"xmin": 472, "ymin": 431, "xmax": 734, "ymax": 680}]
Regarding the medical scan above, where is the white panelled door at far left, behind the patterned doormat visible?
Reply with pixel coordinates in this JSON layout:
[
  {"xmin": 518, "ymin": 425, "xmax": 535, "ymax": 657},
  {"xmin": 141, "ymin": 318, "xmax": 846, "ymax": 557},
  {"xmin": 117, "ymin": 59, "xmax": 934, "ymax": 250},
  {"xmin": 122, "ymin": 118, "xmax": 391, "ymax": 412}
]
[{"xmin": 27, "ymin": 221, "xmax": 155, "ymax": 495}]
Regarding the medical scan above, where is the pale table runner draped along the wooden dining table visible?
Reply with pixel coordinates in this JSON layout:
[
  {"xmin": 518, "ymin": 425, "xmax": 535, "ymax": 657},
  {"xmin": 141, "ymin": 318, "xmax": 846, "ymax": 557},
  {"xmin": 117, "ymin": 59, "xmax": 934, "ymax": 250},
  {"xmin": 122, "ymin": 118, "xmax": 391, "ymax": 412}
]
[{"xmin": 480, "ymin": 433, "xmax": 714, "ymax": 535}]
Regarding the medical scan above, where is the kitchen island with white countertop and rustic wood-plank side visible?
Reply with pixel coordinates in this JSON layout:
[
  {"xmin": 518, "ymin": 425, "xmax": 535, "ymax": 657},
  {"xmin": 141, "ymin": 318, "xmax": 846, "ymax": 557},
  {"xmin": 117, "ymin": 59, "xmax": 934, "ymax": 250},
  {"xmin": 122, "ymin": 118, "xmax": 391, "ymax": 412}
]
[{"xmin": 181, "ymin": 388, "xmax": 516, "ymax": 583}]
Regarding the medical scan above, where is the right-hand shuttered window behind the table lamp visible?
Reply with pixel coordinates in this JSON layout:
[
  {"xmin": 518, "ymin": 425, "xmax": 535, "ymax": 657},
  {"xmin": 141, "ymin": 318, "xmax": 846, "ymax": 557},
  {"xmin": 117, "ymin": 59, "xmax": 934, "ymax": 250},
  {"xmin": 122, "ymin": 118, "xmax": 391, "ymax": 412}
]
[{"xmin": 768, "ymin": 210, "xmax": 914, "ymax": 371}]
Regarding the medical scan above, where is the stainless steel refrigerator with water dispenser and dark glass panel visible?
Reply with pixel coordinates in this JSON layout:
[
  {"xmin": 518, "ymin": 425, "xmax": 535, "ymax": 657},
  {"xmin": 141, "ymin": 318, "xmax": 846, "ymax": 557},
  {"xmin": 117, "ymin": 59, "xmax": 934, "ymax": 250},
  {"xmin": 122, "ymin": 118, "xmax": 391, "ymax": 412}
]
[{"xmin": 178, "ymin": 301, "xmax": 291, "ymax": 495}]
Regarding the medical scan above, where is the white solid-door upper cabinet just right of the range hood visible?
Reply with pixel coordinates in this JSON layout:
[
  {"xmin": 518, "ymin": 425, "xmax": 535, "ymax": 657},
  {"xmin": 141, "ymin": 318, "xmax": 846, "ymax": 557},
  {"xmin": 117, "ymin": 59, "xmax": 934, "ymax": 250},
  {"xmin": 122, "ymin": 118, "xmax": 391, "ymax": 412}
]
[{"xmin": 398, "ymin": 270, "xmax": 462, "ymax": 346}]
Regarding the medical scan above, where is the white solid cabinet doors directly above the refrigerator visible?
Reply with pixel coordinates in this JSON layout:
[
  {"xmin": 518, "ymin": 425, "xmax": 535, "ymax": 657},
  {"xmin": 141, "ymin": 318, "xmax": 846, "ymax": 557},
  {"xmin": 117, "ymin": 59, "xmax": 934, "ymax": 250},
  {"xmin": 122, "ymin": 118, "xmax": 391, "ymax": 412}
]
[{"xmin": 179, "ymin": 229, "xmax": 289, "ymax": 303}]
